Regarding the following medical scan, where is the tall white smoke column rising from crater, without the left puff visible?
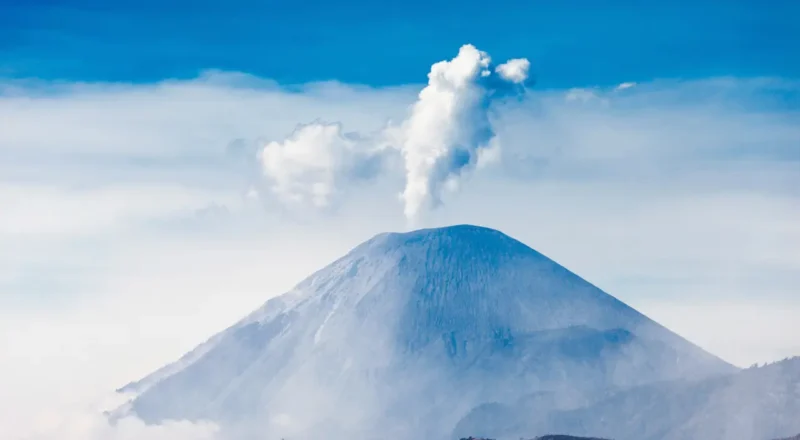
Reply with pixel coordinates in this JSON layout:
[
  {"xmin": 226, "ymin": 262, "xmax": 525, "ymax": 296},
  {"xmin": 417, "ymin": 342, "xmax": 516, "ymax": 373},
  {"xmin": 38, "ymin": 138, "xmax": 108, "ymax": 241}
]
[{"xmin": 392, "ymin": 44, "xmax": 530, "ymax": 218}]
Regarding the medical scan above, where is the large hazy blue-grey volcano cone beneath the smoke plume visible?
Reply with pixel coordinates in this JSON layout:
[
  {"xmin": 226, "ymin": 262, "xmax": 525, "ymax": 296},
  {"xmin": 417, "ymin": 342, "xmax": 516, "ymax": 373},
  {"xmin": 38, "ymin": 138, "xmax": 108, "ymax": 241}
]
[{"xmin": 119, "ymin": 226, "xmax": 732, "ymax": 438}]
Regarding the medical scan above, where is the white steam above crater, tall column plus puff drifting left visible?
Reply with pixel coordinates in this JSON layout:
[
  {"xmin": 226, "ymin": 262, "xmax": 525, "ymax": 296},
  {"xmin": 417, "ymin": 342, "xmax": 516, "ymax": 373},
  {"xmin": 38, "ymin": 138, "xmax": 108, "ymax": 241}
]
[{"xmin": 260, "ymin": 44, "xmax": 530, "ymax": 219}]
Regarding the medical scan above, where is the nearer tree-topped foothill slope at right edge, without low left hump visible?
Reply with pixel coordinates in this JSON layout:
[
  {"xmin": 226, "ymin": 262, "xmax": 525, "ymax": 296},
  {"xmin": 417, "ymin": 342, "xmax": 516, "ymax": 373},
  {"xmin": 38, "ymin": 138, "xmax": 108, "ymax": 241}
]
[{"xmin": 558, "ymin": 358, "xmax": 800, "ymax": 440}]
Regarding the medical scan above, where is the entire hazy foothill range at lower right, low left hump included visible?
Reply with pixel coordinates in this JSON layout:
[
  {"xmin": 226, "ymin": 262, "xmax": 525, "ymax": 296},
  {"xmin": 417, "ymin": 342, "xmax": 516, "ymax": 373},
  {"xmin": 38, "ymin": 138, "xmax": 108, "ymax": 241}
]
[{"xmin": 457, "ymin": 358, "xmax": 800, "ymax": 440}]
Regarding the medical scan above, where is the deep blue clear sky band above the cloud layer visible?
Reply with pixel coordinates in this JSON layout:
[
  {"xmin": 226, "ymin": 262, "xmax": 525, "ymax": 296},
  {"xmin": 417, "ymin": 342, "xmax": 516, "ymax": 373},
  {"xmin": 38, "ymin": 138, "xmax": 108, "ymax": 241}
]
[{"xmin": 0, "ymin": 0, "xmax": 800, "ymax": 88}]
